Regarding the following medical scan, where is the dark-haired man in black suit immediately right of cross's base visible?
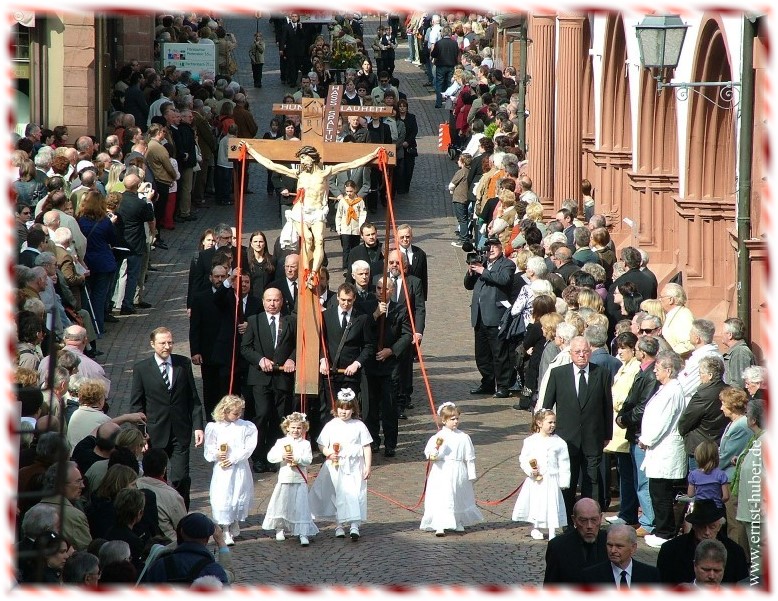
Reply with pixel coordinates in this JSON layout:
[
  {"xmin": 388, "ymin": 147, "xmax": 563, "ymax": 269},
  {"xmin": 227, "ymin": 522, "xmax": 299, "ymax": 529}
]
[{"xmin": 319, "ymin": 282, "xmax": 375, "ymax": 412}]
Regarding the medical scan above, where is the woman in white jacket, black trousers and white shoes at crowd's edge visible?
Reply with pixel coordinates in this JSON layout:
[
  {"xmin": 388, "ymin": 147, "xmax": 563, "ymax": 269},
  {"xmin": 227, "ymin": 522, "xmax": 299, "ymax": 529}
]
[{"xmin": 638, "ymin": 351, "xmax": 687, "ymax": 547}]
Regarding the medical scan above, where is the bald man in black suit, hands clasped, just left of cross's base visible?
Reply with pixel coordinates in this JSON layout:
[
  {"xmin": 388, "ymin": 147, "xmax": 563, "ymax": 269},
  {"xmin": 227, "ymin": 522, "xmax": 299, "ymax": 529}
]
[{"xmin": 240, "ymin": 287, "xmax": 297, "ymax": 472}]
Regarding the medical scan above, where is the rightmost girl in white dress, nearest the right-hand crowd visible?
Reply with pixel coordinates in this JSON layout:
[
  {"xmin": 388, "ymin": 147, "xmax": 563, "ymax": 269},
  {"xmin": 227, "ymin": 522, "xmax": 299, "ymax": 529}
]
[{"xmin": 512, "ymin": 409, "xmax": 570, "ymax": 540}]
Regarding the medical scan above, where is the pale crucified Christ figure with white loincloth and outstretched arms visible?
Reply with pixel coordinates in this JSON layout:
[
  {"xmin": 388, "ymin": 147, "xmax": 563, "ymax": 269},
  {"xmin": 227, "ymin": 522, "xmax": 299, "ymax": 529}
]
[{"xmin": 241, "ymin": 142, "xmax": 380, "ymax": 290}]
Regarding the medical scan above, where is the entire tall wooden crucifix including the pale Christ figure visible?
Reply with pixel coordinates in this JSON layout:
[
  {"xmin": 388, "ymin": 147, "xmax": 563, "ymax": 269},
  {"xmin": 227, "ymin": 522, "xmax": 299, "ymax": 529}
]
[{"xmin": 229, "ymin": 85, "xmax": 396, "ymax": 394}]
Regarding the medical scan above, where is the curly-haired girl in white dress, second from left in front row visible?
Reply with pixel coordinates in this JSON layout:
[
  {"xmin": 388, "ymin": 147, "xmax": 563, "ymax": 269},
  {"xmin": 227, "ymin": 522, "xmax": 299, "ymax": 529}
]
[{"xmin": 262, "ymin": 412, "xmax": 319, "ymax": 547}]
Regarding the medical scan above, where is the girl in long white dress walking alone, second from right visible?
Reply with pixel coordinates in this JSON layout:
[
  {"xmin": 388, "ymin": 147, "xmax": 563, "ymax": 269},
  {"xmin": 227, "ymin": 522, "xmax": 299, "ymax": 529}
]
[{"xmin": 419, "ymin": 402, "xmax": 484, "ymax": 536}]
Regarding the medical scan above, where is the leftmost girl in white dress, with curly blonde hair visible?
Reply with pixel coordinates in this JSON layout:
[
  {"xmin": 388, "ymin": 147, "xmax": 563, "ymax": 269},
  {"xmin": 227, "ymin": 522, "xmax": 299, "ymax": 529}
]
[{"xmin": 204, "ymin": 394, "xmax": 257, "ymax": 545}]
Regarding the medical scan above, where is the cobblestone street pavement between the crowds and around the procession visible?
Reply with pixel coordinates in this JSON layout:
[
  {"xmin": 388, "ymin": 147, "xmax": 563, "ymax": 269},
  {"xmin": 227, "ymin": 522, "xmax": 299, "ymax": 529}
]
[{"xmin": 100, "ymin": 12, "xmax": 656, "ymax": 587}]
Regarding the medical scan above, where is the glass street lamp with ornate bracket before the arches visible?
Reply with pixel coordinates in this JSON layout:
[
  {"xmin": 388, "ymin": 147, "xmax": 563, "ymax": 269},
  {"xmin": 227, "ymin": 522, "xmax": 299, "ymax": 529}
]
[{"xmin": 635, "ymin": 15, "xmax": 740, "ymax": 101}]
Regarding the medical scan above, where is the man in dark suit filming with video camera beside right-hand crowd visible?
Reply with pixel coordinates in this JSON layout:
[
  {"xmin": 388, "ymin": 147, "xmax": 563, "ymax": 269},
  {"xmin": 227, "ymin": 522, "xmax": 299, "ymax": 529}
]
[{"xmin": 463, "ymin": 238, "xmax": 516, "ymax": 399}]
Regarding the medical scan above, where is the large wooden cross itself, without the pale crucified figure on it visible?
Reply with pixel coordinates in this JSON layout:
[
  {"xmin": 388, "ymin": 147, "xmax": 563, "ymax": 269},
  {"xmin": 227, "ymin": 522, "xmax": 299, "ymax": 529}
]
[{"xmin": 228, "ymin": 85, "xmax": 397, "ymax": 395}]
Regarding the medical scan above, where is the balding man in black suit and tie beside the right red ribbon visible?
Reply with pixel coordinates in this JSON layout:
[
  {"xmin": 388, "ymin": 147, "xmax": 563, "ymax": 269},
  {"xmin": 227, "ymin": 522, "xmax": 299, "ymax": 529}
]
[{"xmin": 373, "ymin": 248, "xmax": 427, "ymax": 419}]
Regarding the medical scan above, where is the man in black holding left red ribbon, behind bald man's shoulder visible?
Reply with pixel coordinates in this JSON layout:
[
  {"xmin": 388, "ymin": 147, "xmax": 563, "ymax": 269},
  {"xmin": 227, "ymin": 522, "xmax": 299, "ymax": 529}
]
[{"xmin": 213, "ymin": 272, "xmax": 263, "ymax": 408}]
